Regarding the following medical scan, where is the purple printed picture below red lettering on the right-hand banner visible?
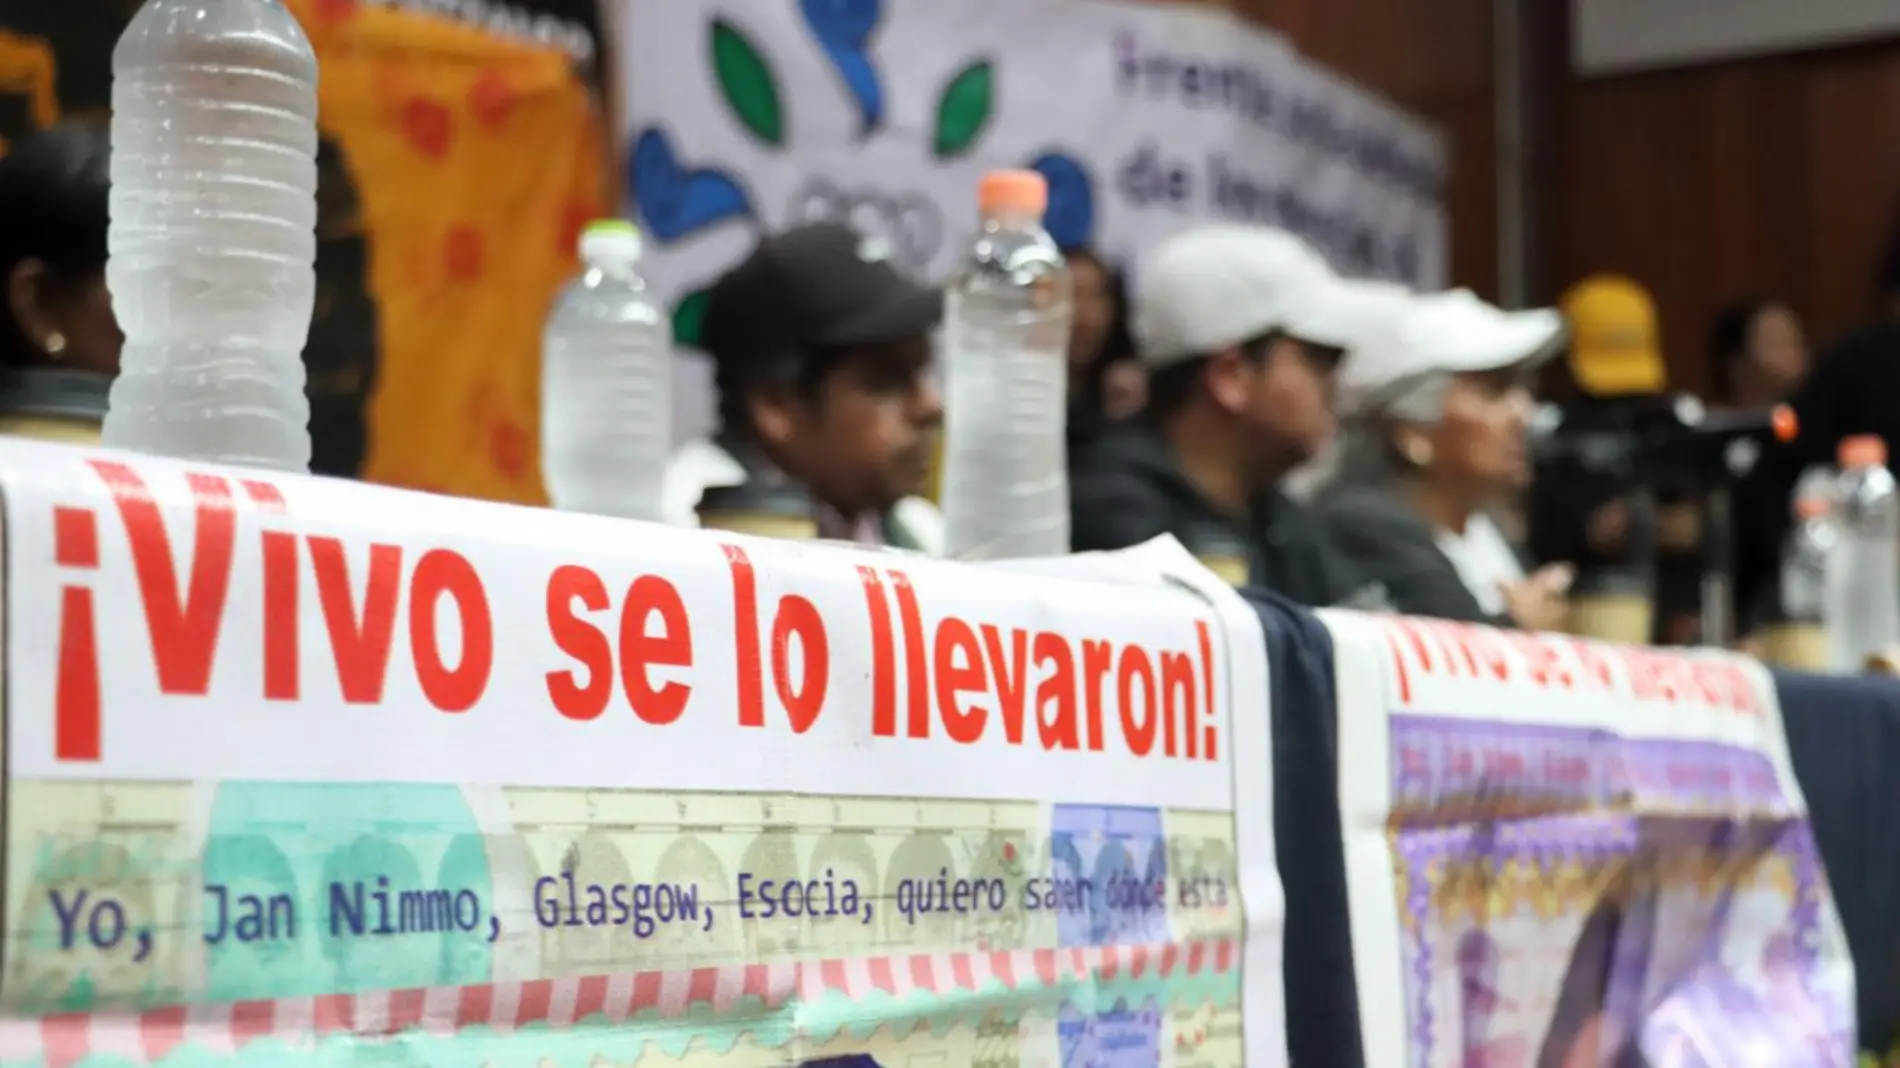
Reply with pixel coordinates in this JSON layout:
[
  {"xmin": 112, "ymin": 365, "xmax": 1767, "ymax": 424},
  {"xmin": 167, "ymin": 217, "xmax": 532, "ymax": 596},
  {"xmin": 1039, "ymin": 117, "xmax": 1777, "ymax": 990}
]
[{"xmin": 1389, "ymin": 713, "xmax": 1854, "ymax": 1068}]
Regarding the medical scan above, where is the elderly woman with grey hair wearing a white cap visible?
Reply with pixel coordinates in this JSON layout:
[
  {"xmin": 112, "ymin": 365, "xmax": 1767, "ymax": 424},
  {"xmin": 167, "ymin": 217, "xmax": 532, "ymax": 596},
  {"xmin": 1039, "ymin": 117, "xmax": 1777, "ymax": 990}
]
[{"xmin": 1319, "ymin": 289, "xmax": 1569, "ymax": 629}]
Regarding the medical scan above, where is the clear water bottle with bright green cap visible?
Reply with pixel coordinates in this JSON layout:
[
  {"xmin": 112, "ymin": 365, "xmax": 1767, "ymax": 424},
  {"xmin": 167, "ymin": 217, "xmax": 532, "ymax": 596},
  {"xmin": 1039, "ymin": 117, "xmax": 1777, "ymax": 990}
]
[{"xmin": 542, "ymin": 219, "xmax": 673, "ymax": 523}]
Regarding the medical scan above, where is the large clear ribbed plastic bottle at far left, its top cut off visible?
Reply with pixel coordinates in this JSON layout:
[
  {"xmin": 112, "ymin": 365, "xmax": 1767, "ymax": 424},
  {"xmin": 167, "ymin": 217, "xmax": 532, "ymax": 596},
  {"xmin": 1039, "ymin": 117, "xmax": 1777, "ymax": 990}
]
[{"xmin": 103, "ymin": 0, "xmax": 317, "ymax": 469}]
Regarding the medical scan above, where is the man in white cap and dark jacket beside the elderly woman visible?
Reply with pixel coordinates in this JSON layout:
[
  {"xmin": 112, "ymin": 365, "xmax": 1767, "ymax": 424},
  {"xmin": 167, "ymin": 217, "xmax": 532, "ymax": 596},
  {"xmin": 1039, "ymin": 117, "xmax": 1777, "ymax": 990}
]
[{"xmin": 1070, "ymin": 224, "xmax": 1364, "ymax": 604}]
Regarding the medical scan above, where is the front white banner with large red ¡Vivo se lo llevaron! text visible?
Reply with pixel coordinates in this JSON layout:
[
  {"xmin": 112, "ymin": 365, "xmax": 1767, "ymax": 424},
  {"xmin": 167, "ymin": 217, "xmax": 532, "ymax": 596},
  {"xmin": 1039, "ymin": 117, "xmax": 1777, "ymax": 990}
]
[{"xmin": 0, "ymin": 439, "xmax": 1284, "ymax": 1068}]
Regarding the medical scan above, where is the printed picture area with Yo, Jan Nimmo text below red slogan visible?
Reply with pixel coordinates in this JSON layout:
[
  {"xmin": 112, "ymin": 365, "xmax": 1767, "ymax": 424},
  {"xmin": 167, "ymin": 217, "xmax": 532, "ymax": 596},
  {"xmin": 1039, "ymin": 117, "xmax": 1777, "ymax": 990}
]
[{"xmin": 6, "ymin": 783, "xmax": 1241, "ymax": 1064}]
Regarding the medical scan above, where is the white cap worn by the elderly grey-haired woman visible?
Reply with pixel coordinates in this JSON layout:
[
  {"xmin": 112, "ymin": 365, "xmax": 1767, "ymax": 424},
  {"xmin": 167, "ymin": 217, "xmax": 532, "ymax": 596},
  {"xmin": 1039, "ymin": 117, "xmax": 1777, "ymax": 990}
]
[{"xmin": 1338, "ymin": 289, "xmax": 1566, "ymax": 412}]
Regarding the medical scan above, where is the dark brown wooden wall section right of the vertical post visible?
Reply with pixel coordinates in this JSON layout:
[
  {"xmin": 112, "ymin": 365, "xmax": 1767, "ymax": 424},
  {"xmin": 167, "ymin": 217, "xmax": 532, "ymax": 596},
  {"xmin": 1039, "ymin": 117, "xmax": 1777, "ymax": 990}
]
[{"xmin": 1535, "ymin": 20, "xmax": 1900, "ymax": 390}]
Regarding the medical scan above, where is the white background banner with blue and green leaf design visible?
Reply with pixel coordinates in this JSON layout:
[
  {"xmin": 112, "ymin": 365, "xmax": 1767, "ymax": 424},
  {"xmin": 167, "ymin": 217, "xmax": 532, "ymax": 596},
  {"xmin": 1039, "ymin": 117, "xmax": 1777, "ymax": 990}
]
[{"xmin": 619, "ymin": 0, "xmax": 1446, "ymax": 433}]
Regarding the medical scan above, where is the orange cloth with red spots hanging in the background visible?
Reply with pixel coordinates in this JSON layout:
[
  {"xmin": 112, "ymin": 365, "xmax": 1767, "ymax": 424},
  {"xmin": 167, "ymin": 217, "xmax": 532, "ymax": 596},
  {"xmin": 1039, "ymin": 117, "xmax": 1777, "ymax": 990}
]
[{"xmin": 289, "ymin": 0, "xmax": 604, "ymax": 504}]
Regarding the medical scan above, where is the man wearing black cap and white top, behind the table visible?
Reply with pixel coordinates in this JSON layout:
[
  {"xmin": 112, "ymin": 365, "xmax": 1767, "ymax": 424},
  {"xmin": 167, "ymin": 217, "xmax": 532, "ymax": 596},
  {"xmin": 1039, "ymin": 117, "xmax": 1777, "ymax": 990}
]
[{"xmin": 665, "ymin": 222, "xmax": 942, "ymax": 553}]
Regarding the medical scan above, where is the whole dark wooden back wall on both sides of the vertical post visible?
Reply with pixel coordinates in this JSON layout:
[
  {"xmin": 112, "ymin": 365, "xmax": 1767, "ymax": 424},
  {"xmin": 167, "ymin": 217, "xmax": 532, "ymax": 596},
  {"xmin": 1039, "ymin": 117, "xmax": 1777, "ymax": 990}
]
[{"xmin": 1200, "ymin": 0, "xmax": 1900, "ymax": 402}]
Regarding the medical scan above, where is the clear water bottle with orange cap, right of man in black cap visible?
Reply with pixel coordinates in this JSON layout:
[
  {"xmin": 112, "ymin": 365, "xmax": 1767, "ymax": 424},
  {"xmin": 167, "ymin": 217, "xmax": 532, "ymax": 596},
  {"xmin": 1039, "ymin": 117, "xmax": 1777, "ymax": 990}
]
[{"xmin": 942, "ymin": 171, "xmax": 1074, "ymax": 559}]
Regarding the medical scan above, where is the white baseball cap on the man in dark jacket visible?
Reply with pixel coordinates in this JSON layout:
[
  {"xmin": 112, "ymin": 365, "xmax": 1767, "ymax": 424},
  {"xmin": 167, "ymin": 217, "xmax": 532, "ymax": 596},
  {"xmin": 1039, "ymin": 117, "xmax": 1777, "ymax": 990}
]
[{"xmin": 1131, "ymin": 224, "xmax": 1353, "ymax": 367}]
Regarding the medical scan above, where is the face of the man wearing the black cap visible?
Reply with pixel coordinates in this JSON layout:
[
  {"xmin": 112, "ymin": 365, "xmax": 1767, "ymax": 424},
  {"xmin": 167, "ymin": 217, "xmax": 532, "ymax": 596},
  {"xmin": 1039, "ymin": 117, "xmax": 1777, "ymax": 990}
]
[{"xmin": 773, "ymin": 334, "xmax": 942, "ymax": 513}]
